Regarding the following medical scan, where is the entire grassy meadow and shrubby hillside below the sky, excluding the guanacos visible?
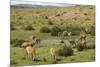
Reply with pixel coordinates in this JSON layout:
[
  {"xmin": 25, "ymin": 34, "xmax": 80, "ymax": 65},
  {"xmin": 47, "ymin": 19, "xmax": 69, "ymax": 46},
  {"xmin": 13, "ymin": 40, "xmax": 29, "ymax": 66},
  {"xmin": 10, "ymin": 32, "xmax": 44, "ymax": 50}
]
[{"xmin": 10, "ymin": 5, "xmax": 95, "ymax": 66}]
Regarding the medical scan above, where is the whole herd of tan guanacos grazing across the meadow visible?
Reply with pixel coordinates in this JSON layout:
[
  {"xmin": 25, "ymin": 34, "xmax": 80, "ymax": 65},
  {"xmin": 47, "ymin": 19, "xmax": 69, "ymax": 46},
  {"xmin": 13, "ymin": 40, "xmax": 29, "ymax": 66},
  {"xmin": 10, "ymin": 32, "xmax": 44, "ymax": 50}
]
[{"xmin": 21, "ymin": 31, "xmax": 86, "ymax": 61}]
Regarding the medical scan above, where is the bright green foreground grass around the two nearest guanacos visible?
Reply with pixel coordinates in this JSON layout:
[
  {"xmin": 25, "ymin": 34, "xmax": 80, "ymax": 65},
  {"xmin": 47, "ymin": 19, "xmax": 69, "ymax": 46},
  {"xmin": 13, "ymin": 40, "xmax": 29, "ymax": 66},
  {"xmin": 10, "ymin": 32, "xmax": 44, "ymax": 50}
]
[{"xmin": 11, "ymin": 46, "xmax": 95, "ymax": 65}]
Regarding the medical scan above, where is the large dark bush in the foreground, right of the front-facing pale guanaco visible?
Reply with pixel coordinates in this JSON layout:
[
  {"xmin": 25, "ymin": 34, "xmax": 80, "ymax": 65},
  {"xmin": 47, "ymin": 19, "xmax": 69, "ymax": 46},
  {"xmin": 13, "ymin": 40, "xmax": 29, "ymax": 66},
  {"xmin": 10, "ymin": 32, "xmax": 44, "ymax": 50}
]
[{"xmin": 57, "ymin": 46, "xmax": 73, "ymax": 57}]
